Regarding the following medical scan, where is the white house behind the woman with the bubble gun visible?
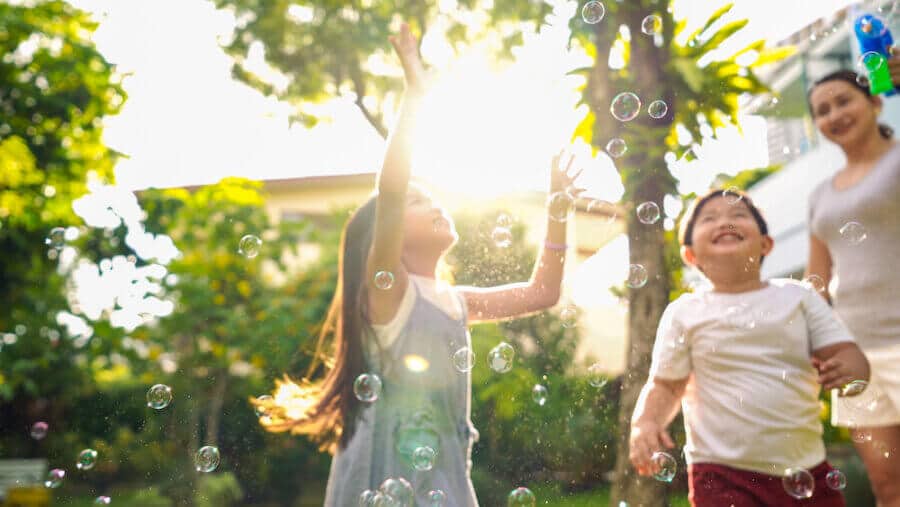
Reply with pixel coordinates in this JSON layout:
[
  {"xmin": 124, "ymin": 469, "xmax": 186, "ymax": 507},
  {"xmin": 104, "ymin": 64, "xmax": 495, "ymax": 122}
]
[{"xmin": 747, "ymin": 2, "xmax": 900, "ymax": 278}]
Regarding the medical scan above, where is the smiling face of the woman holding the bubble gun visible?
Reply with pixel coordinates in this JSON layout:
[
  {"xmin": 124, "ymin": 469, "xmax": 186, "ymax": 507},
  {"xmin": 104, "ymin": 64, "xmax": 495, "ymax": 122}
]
[{"xmin": 809, "ymin": 80, "xmax": 881, "ymax": 147}]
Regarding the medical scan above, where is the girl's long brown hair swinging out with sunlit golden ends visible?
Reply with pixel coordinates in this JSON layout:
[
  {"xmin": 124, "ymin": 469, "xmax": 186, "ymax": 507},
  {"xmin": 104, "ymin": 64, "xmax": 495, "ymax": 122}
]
[{"xmin": 251, "ymin": 196, "xmax": 375, "ymax": 452}]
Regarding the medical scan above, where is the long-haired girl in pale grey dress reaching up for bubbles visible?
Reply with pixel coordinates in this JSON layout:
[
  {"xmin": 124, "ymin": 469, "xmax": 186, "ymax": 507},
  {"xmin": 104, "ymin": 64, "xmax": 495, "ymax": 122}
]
[{"xmin": 261, "ymin": 21, "xmax": 583, "ymax": 507}]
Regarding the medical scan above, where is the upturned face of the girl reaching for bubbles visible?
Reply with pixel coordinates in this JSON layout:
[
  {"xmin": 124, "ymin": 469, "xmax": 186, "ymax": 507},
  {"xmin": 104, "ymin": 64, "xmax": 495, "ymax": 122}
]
[{"xmin": 404, "ymin": 185, "xmax": 459, "ymax": 251}]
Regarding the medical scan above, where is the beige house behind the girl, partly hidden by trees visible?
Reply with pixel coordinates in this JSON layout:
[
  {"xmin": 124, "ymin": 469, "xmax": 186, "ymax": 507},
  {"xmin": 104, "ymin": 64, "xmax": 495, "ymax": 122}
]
[{"xmin": 263, "ymin": 172, "xmax": 627, "ymax": 374}]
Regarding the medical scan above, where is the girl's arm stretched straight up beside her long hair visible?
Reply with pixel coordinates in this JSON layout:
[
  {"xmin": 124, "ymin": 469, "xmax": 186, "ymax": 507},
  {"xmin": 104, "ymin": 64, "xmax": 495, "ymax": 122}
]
[{"xmin": 366, "ymin": 24, "xmax": 425, "ymax": 323}]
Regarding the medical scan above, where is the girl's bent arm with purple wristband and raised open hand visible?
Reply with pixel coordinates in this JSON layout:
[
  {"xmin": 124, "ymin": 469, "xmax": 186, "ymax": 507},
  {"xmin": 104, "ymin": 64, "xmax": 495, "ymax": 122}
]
[{"xmin": 460, "ymin": 152, "xmax": 584, "ymax": 322}]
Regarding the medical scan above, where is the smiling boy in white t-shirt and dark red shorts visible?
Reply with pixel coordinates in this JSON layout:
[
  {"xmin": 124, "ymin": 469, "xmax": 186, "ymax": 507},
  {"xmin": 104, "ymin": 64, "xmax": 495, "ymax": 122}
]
[{"xmin": 629, "ymin": 190, "xmax": 869, "ymax": 507}]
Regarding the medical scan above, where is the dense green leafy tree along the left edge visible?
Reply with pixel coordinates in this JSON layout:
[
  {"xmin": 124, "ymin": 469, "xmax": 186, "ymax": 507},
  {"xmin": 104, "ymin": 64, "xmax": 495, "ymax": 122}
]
[{"xmin": 0, "ymin": 1, "xmax": 125, "ymax": 464}]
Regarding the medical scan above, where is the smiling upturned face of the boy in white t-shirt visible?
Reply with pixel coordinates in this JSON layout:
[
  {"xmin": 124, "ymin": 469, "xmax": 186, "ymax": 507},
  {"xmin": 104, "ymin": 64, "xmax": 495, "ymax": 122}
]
[{"xmin": 682, "ymin": 197, "xmax": 773, "ymax": 281}]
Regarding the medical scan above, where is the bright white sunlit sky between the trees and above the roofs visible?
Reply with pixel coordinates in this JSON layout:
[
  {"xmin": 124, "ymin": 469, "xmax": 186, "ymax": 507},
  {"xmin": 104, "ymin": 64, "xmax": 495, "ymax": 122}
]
[{"xmin": 58, "ymin": 0, "xmax": 864, "ymax": 199}]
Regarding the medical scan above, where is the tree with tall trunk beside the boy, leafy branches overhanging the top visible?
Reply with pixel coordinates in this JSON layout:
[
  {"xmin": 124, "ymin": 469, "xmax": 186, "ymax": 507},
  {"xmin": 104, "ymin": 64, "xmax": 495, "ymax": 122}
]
[{"xmin": 216, "ymin": 0, "xmax": 789, "ymax": 506}]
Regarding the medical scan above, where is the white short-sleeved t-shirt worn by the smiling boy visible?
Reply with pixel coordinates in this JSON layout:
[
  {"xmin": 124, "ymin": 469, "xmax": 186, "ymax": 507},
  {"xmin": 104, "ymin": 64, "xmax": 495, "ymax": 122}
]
[{"xmin": 650, "ymin": 280, "xmax": 853, "ymax": 475}]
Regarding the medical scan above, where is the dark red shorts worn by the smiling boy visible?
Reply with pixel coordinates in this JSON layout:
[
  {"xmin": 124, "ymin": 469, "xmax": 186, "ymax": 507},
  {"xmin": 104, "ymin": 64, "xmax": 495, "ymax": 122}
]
[{"xmin": 688, "ymin": 461, "xmax": 846, "ymax": 507}]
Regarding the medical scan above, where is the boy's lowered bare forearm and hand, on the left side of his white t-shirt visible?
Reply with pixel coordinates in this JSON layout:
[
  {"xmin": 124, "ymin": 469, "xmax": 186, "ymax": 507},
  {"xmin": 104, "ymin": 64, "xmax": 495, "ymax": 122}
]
[{"xmin": 628, "ymin": 377, "xmax": 688, "ymax": 475}]
